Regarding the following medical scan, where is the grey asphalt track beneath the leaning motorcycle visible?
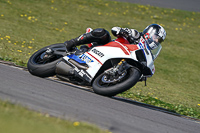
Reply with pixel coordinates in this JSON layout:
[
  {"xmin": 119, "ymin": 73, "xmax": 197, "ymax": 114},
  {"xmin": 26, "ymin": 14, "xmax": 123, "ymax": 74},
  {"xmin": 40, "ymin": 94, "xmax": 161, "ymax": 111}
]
[{"xmin": 0, "ymin": 64, "xmax": 200, "ymax": 133}]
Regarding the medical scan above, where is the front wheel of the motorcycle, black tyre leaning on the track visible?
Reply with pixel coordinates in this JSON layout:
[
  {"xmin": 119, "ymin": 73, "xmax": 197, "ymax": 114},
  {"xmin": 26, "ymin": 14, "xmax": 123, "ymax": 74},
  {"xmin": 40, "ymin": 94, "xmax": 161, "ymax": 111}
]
[{"xmin": 92, "ymin": 67, "xmax": 141, "ymax": 96}]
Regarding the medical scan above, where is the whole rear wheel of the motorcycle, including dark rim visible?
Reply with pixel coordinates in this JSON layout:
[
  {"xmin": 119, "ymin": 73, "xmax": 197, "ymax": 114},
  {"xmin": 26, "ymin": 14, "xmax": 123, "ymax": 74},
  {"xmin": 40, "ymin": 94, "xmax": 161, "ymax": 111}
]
[{"xmin": 27, "ymin": 43, "xmax": 66, "ymax": 77}]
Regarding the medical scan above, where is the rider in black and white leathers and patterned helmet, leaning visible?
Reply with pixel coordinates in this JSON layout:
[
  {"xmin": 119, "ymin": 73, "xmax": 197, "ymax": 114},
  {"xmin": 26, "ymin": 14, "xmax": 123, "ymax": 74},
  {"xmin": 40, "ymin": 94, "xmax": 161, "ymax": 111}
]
[{"xmin": 64, "ymin": 24, "xmax": 166, "ymax": 51}]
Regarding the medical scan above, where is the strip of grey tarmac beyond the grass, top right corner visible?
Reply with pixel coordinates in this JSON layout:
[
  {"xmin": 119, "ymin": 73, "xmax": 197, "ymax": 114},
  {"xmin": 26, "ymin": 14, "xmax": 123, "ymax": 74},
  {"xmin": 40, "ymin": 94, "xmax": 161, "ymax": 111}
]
[{"xmin": 115, "ymin": 0, "xmax": 200, "ymax": 12}]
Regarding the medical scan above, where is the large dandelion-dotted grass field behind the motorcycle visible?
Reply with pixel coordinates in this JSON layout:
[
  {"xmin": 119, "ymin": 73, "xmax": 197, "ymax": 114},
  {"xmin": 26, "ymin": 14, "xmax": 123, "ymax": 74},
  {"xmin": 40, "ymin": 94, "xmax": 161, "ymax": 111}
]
[{"xmin": 0, "ymin": 0, "xmax": 200, "ymax": 118}]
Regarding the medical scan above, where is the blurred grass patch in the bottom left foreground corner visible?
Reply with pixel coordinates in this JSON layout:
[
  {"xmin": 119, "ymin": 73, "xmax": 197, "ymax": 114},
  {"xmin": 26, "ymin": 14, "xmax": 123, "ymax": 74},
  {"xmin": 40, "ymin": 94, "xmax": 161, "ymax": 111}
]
[{"xmin": 0, "ymin": 101, "xmax": 109, "ymax": 133}]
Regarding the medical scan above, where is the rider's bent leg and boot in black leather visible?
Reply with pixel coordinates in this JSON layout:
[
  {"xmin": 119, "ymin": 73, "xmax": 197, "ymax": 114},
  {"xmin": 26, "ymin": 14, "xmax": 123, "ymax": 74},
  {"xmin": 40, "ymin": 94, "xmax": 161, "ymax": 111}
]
[{"xmin": 64, "ymin": 28, "xmax": 111, "ymax": 51}]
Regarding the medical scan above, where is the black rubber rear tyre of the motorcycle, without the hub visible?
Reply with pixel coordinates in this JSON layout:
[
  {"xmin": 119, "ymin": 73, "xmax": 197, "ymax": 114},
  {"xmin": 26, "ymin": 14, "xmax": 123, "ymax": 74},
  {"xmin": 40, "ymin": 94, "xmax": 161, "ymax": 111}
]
[{"xmin": 27, "ymin": 43, "xmax": 66, "ymax": 77}]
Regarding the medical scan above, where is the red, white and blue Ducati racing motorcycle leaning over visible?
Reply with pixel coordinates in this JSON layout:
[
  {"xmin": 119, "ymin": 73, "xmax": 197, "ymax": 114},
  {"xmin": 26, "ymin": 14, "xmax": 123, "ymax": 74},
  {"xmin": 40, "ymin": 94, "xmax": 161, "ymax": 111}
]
[{"xmin": 27, "ymin": 30, "xmax": 162, "ymax": 96}]
